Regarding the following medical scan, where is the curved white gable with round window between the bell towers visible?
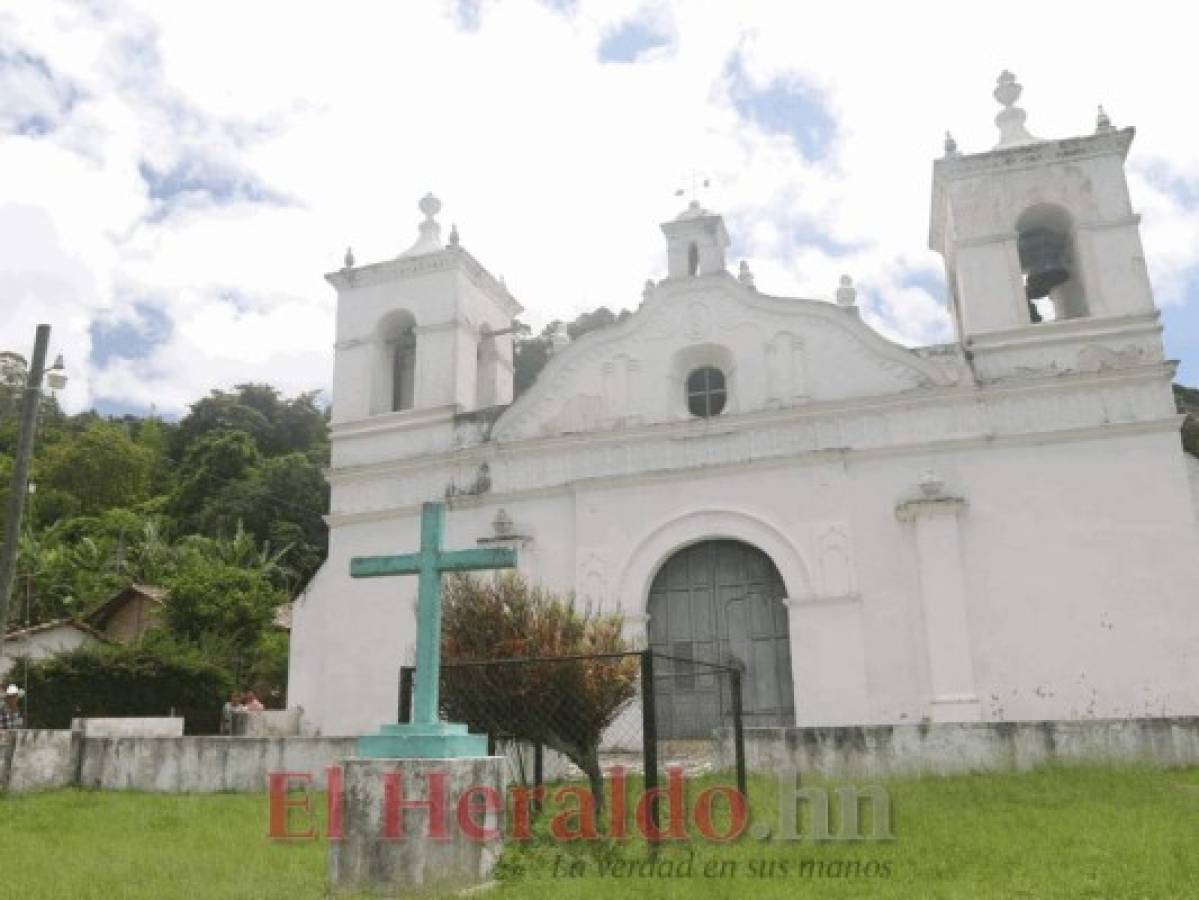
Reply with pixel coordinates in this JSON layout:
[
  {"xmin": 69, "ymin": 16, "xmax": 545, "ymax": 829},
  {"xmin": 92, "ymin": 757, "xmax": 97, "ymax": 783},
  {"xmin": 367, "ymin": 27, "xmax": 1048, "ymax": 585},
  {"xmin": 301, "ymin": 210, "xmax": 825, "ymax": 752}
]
[{"xmin": 493, "ymin": 276, "xmax": 959, "ymax": 441}]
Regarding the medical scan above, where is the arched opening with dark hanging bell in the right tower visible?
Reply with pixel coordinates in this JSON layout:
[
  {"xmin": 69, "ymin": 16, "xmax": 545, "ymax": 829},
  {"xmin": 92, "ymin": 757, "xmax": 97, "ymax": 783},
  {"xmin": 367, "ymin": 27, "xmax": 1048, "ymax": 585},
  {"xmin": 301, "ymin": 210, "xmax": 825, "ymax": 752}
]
[{"xmin": 1016, "ymin": 204, "xmax": 1087, "ymax": 324}]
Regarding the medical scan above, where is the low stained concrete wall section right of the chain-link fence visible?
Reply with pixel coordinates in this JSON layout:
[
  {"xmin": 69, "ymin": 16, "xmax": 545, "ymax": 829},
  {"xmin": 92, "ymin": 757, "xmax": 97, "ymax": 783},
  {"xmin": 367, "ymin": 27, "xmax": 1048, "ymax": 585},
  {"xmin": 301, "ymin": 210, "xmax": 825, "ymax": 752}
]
[{"xmin": 718, "ymin": 717, "xmax": 1199, "ymax": 778}]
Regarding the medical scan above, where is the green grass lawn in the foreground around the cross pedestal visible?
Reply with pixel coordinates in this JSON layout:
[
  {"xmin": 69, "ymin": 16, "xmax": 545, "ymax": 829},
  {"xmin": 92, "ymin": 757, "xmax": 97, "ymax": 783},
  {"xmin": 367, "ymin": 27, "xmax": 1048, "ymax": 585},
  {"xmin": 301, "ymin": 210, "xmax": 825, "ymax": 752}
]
[{"xmin": 0, "ymin": 767, "xmax": 1199, "ymax": 900}]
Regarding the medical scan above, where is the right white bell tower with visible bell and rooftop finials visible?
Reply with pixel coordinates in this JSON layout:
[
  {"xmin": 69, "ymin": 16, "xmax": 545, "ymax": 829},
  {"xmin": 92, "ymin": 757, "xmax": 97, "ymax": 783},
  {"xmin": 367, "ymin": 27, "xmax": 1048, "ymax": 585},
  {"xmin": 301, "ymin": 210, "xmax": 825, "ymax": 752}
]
[{"xmin": 929, "ymin": 72, "xmax": 1161, "ymax": 375}]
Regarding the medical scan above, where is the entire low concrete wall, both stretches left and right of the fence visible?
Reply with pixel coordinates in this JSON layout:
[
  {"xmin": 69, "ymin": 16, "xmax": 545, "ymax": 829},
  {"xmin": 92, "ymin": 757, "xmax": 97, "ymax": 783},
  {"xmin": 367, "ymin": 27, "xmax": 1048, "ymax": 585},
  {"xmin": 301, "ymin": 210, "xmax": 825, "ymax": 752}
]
[{"xmin": 0, "ymin": 717, "xmax": 1199, "ymax": 793}]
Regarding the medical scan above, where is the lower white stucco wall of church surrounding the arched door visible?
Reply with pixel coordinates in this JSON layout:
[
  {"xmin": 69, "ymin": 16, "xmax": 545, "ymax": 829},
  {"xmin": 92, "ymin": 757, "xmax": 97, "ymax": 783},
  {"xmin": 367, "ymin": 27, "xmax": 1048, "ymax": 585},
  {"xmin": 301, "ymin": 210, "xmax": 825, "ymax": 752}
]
[{"xmin": 291, "ymin": 412, "xmax": 1199, "ymax": 733}]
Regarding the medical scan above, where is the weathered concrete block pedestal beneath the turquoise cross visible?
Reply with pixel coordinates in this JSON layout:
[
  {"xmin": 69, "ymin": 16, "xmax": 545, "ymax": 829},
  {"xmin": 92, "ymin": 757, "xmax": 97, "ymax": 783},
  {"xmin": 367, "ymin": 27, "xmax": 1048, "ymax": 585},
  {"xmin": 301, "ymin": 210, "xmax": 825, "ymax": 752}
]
[{"xmin": 329, "ymin": 756, "xmax": 506, "ymax": 895}]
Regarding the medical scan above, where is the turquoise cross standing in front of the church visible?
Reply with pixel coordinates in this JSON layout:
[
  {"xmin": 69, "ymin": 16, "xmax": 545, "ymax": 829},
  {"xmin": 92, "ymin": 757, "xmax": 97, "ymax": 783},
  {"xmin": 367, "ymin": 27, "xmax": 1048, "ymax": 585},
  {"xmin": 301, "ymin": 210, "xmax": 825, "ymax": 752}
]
[{"xmin": 350, "ymin": 503, "xmax": 517, "ymax": 756}]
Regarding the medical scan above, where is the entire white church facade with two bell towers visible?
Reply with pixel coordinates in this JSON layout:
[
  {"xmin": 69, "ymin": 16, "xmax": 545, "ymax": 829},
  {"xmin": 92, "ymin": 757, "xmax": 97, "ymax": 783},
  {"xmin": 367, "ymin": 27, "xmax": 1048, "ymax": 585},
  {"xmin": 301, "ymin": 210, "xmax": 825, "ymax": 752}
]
[{"xmin": 289, "ymin": 73, "xmax": 1199, "ymax": 735}]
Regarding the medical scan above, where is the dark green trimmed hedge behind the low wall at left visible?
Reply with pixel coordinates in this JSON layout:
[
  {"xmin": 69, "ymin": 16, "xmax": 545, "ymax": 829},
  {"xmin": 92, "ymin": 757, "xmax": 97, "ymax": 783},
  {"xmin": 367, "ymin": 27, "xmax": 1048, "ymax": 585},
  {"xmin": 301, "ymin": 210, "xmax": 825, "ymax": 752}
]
[{"xmin": 28, "ymin": 636, "xmax": 231, "ymax": 733}]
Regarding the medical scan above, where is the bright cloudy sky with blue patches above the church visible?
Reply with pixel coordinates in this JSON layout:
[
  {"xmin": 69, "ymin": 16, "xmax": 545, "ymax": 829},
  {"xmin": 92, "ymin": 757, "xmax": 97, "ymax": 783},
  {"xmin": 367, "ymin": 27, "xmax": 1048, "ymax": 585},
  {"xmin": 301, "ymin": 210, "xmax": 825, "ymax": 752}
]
[{"xmin": 0, "ymin": 0, "xmax": 1199, "ymax": 415}]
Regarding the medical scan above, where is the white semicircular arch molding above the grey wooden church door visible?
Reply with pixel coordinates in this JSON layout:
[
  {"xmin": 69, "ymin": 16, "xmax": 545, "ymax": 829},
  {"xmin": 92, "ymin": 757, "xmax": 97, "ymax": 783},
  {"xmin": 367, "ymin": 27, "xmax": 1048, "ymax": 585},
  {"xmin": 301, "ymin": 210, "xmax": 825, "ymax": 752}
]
[{"xmin": 619, "ymin": 509, "xmax": 812, "ymax": 615}]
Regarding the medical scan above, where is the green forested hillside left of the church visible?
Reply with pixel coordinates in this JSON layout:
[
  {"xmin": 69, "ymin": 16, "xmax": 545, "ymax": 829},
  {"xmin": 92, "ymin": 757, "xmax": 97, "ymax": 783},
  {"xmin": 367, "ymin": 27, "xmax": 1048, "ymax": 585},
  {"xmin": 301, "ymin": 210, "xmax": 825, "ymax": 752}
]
[{"xmin": 0, "ymin": 385, "xmax": 329, "ymax": 688}]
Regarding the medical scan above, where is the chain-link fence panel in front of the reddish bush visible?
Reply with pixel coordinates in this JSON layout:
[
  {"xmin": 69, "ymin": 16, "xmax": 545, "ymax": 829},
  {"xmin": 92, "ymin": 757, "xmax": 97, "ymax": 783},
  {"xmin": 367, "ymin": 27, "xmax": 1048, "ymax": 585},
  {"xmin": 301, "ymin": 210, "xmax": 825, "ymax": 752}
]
[{"xmin": 398, "ymin": 651, "xmax": 746, "ymax": 810}]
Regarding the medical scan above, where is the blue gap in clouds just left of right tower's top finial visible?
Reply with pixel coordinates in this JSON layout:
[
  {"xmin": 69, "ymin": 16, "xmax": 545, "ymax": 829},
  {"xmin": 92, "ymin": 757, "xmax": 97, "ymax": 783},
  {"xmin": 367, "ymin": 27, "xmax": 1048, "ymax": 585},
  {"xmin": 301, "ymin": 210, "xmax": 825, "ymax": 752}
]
[{"xmin": 725, "ymin": 54, "xmax": 837, "ymax": 161}]
